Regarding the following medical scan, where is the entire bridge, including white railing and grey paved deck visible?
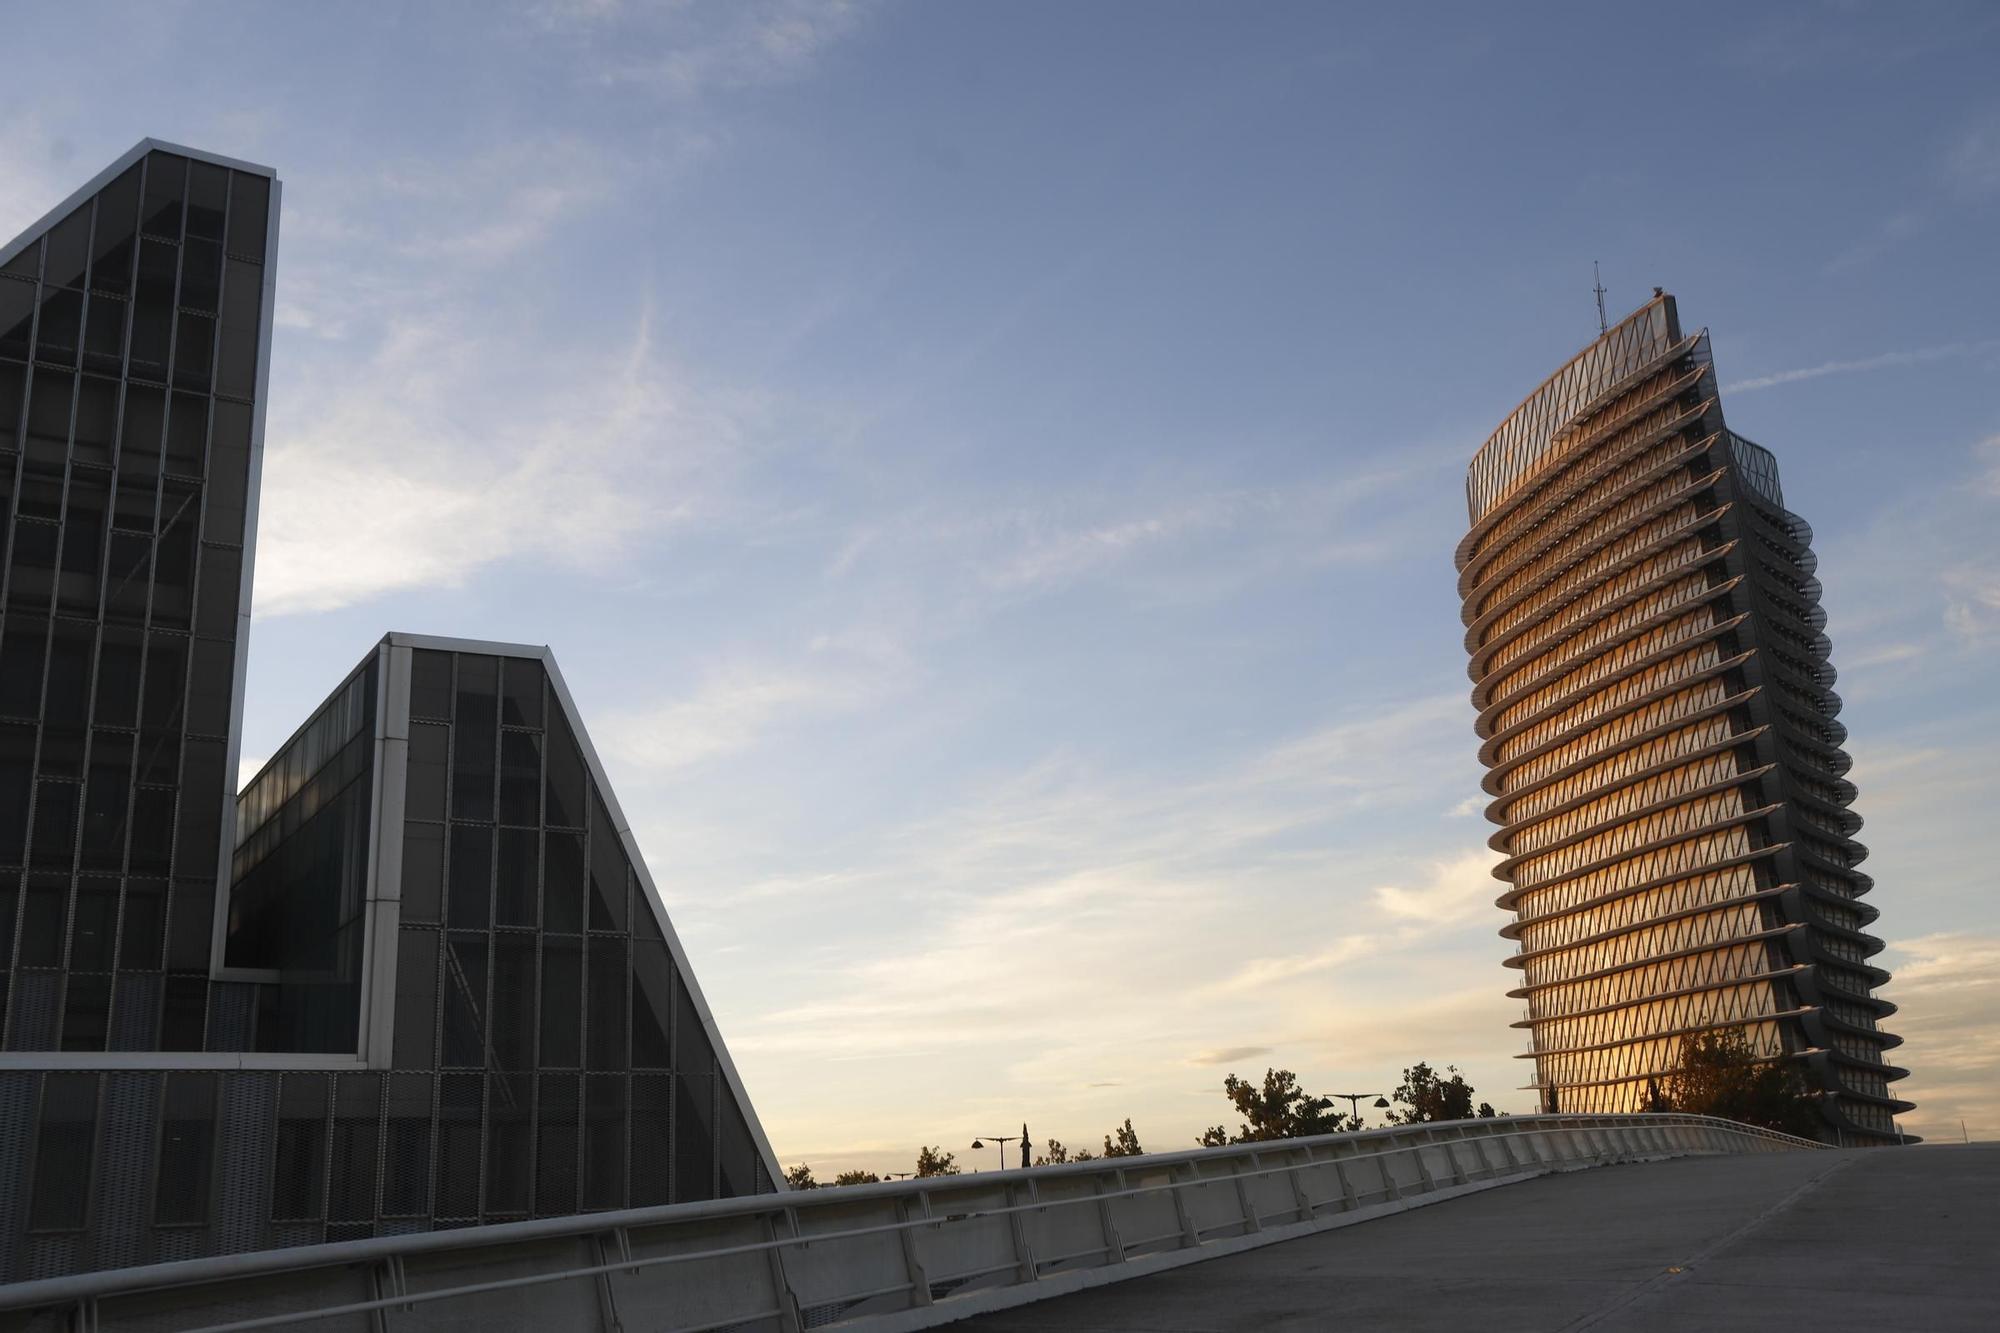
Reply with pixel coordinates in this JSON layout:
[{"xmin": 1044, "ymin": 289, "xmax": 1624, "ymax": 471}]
[{"xmin": 0, "ymin": 1115, "xmax": 2000, "ymax": 1333}]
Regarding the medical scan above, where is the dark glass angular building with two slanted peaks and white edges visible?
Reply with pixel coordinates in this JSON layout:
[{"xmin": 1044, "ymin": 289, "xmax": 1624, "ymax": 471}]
[{"xmin": 0, "ymin": 140, "xmax": 780, "ymax": 1281}]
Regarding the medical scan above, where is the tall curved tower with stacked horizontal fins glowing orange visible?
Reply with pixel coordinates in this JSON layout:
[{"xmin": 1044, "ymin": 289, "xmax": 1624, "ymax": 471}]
[{"xmin": 1456, "ymin": 294, "xmax": 1910, "ymax": 1141}]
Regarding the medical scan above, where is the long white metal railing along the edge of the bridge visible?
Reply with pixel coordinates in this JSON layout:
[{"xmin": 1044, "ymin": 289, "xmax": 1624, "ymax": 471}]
[{"xmin": 0, "ymin": 1115, "xmax": 1822, "ymax": 1333}]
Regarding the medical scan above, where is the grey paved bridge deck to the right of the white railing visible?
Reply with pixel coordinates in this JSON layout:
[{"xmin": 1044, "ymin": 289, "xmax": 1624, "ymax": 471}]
[{"xmin": 954, "ymin": 1145, "xmax": 2000, "ymax": 1333}]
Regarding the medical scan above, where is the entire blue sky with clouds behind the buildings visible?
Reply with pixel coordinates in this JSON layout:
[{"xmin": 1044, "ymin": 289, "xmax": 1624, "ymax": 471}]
[{"xmin": 0, "ymin": 0, "xmax": 2000, "ymax": 1175}]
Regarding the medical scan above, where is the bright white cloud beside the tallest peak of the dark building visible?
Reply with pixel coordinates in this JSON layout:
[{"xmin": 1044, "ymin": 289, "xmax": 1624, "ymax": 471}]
[{"xmin": 256, "ymin": 296, "xmax": 736, "ymax": 614}]
